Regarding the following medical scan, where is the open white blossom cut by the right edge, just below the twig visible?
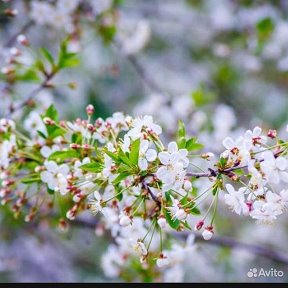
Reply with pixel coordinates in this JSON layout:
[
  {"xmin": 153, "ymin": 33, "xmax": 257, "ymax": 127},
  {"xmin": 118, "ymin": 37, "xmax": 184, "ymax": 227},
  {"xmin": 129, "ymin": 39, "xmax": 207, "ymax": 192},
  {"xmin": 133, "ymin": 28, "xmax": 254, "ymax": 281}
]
[{"xmin": 260, "ymin": 151, "xmax": 288, "ymax": 184}]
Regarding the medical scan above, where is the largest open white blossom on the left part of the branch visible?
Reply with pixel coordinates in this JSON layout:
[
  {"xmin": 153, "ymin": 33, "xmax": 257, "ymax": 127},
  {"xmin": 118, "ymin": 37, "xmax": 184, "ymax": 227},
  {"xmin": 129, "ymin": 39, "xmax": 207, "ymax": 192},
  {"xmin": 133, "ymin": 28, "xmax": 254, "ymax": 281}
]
[{"xmin": 40, "ymin": 161, "xmax": 69, "ymax": 195}]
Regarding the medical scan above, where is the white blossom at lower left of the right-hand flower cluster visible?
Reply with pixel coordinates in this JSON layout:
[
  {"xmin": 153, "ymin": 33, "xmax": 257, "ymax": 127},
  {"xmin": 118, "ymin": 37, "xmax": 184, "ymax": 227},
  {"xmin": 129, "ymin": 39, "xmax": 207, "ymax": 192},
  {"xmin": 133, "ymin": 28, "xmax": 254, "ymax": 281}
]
[{"xmin": 224, "ymin": 184, "xmax": 249, "ymax": 215}]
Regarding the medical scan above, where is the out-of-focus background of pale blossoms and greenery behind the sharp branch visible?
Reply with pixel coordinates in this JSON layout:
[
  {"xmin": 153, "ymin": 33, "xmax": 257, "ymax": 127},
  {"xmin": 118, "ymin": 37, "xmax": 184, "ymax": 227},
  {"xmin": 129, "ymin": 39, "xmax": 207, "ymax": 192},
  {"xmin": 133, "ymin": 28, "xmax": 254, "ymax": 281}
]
[{"xmin": 0, "ymin": 0, "xmax": 288, "ymax": 282}]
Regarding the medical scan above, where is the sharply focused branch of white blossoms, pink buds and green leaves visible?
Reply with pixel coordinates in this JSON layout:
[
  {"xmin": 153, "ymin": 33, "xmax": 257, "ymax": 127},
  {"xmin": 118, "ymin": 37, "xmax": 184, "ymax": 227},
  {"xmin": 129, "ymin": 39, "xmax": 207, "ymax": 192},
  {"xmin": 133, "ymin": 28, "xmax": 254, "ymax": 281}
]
[{"xmin": 0, "ymin": 105, "xmax": 288, "ymax": 275}]
